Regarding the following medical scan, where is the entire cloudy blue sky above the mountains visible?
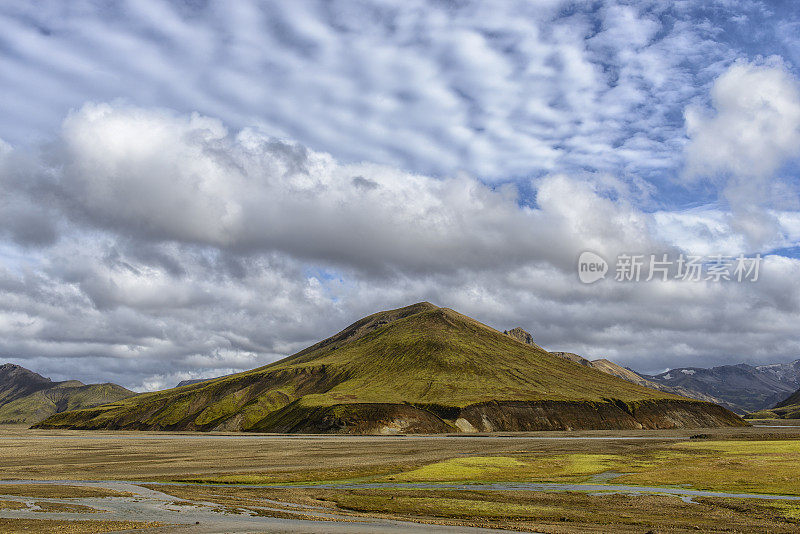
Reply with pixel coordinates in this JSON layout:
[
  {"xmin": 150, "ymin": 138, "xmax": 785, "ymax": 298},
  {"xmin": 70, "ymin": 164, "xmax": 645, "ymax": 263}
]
[{"xmin": 0, "ymin": 0, "xmax": 800, "ymax": 391}]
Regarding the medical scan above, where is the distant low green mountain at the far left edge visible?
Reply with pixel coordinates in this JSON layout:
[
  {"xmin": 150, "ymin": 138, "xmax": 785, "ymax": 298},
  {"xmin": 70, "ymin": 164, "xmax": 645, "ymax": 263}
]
[{"xmin": 0, "ymin": 363, "xmax": 135, "ymax": 424}]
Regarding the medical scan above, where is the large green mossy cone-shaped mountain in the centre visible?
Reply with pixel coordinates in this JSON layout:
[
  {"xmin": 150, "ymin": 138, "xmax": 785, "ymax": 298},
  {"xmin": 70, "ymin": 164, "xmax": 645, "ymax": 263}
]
[{"xmin": 36, "ymin": 302, "xmax": 746, "ymax": 433}]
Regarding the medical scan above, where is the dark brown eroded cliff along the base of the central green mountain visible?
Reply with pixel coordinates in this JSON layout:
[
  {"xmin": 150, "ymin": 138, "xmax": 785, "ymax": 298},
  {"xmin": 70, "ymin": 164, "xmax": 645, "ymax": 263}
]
[{"xmin": 40, "ymin": 399, "xmax": 747, "ymax": 434}]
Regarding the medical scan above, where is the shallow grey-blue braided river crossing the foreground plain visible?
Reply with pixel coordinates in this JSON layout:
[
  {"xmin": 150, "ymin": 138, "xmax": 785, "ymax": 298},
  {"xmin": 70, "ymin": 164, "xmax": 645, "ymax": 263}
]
[{"xmin": 0, "ymin": 480, "xmax": 800, "ymax": 534}]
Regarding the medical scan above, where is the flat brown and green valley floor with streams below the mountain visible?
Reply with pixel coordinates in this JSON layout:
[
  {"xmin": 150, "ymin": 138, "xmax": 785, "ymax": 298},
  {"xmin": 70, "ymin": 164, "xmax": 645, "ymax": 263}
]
[{"xmin": 0, "ymin": 426, "xmax": 800, "ymax": 533}]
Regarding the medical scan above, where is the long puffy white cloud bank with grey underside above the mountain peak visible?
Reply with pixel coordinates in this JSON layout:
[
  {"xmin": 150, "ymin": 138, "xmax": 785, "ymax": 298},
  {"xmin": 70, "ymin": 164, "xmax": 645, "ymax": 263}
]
[{"xmin": 44, "ymin": 104, "xmax": 664, "ymax": 272}]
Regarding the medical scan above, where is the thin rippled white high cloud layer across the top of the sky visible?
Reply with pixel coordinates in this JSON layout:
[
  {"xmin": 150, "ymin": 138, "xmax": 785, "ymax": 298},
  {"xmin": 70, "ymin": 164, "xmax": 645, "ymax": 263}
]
[{"xmin": 0, "ymin": 0, "xmax": 744, "ymax": 181}]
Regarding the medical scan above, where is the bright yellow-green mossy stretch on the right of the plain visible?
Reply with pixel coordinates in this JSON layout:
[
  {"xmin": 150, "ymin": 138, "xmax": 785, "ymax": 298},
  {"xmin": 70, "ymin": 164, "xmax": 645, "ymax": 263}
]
[{"xmin": 382, "ymin": 440, "xmax": 800, "ymax": 495}]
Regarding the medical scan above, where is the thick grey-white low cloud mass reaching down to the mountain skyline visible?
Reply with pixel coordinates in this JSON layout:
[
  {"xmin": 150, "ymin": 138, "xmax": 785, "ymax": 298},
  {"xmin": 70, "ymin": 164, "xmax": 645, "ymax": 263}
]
[{"xmin": 0, "ymin": 100, "xmax": 800, "ymax": 389}]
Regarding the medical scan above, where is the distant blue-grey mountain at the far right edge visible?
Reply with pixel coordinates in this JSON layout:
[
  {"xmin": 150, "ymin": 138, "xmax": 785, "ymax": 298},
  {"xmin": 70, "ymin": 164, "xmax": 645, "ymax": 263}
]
[{"xmin": 642, "ymin": 361, "xmax": 800, "ymax": 414}]
